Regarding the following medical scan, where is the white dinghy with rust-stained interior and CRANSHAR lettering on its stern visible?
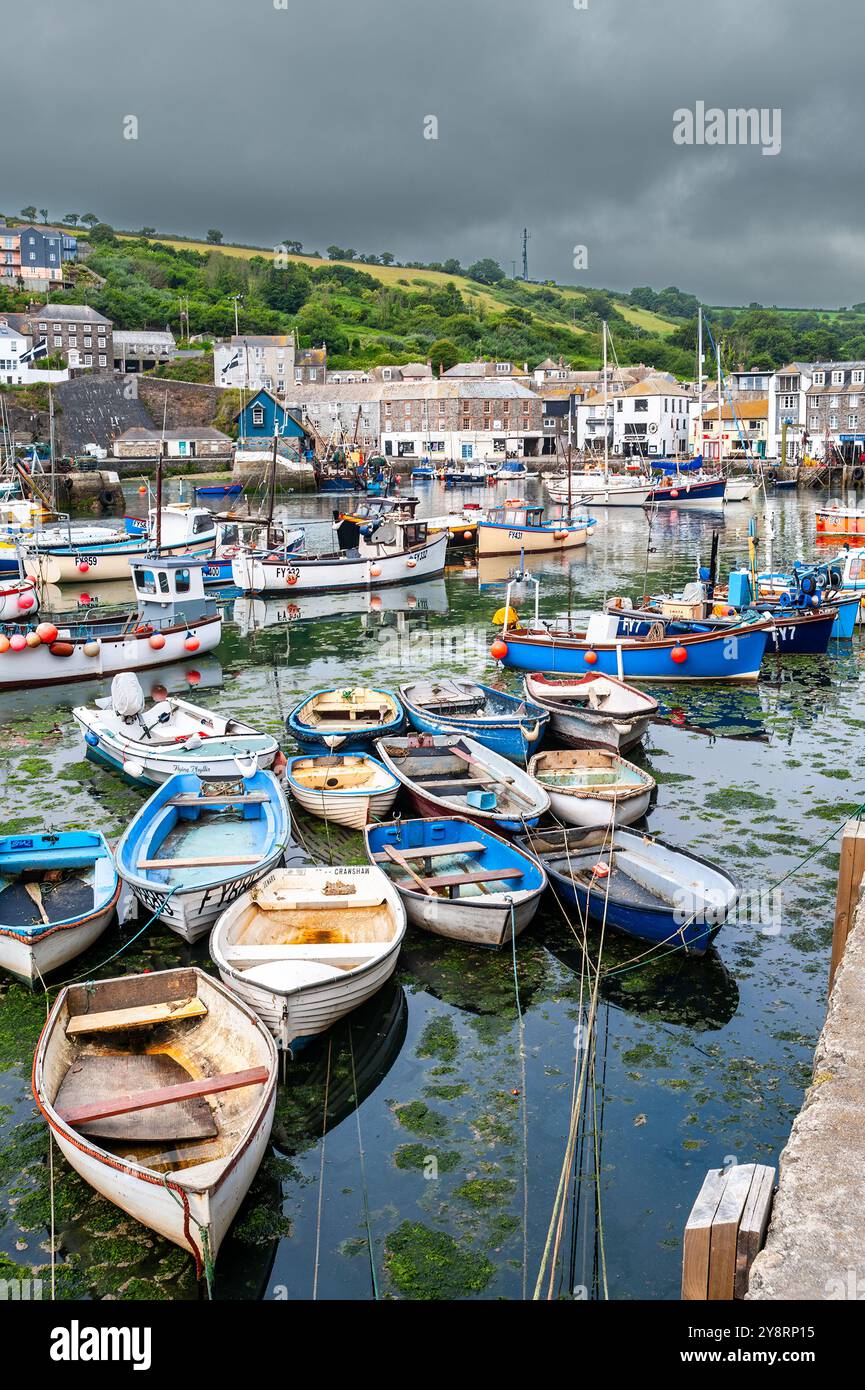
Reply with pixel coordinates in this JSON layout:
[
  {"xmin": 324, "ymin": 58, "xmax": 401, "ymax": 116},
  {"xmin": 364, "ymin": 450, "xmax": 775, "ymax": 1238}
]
[{"xmin": 210, "ymin": 865, "xmax": 406, "ymax": 1052}]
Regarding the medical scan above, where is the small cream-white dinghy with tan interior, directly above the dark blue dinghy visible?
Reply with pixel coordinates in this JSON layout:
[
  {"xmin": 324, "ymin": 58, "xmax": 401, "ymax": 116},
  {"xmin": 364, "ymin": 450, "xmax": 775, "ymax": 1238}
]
[{"xmin": 528, "ymin": 748, "xmax": 658, "ymax": 828}]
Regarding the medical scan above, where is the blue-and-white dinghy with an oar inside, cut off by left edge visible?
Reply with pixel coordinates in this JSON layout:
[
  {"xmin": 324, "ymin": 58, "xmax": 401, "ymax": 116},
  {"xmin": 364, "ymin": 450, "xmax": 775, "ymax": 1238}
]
[{"xmin": 0, "ymin": 830, "xmax": 120, "ymax": 984}]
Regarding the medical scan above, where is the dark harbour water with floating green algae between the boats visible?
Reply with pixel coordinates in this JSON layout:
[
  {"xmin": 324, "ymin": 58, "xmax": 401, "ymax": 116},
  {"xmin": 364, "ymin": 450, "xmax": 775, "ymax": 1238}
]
[{"xmin": 0, "ymin": 485, "xmax": 865, "ymax": 1300}]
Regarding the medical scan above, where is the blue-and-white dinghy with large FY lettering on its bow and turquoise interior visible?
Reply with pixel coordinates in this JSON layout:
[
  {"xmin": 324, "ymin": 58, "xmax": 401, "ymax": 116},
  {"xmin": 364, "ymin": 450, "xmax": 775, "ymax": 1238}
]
[{"xmin": 115, "ymin": 771, "xmax": 291, "ymax": 941}]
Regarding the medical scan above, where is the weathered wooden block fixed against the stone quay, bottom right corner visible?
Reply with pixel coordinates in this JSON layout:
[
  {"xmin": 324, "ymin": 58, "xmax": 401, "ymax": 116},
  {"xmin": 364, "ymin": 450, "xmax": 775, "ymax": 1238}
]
[{"xmin": 681, "ymin": 1163, "xmax": 775, "ymax": 1302}]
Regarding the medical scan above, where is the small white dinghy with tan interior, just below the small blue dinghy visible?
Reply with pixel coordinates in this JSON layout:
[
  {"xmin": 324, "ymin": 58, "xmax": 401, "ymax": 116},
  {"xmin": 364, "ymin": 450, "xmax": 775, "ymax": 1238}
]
[{"xmin": 285, "ymin": 753, "xmax": 399, "ymax": 830}]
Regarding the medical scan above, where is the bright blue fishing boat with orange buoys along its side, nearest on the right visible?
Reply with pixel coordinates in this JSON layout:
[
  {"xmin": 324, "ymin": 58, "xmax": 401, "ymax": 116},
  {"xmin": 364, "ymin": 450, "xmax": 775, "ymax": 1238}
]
[{"xmin": 491, "ymin": 613, "xmax": 770, "ymax": 681}]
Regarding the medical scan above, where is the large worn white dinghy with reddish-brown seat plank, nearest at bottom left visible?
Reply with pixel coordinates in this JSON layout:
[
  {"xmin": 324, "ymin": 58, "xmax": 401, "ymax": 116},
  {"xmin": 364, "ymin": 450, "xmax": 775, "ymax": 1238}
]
[{"xmin": 32, "ymin": 969, "xmax": 278, "ymax": 1275}]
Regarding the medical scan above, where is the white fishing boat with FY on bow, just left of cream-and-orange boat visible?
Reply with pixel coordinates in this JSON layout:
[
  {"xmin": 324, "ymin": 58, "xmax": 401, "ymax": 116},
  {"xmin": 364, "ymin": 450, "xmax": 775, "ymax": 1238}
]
[{"xmin": 232, "ymin": 517, "xmax": 448, "ymax": 595}]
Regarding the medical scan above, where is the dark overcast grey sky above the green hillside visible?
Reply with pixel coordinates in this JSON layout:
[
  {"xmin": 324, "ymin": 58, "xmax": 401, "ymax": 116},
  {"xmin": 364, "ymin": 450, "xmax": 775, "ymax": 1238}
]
[{"xmin": 0, "ymin": 0, "xmax": 865, "ymax": 306}]
